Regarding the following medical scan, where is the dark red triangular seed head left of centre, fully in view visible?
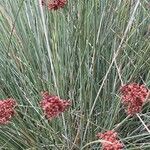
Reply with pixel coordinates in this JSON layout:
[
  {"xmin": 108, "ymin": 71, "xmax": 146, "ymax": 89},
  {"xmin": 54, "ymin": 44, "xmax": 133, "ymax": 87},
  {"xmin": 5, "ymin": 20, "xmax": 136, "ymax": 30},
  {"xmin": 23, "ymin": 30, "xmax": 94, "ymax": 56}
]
[{"xmin": 40, "ymin": 92, "xmax": 71, "ymax": 120}]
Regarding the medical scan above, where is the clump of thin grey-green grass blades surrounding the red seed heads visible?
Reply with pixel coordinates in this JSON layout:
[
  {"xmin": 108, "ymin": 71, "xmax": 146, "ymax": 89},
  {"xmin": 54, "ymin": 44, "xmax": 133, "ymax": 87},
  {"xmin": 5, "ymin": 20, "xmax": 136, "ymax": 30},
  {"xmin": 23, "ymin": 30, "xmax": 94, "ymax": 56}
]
[{"xmin": 0, "ymin": 0, "xmax": 150, "ymax": 150}]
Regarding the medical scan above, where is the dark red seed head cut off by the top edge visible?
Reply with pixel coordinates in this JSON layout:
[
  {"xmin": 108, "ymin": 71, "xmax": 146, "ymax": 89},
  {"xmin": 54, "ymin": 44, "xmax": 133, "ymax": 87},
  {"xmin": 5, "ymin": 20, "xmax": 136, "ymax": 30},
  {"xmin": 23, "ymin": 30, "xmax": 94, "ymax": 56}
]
[{"xmin": 42, "ymin": 0, "xmax": 67, "ymax": 10}]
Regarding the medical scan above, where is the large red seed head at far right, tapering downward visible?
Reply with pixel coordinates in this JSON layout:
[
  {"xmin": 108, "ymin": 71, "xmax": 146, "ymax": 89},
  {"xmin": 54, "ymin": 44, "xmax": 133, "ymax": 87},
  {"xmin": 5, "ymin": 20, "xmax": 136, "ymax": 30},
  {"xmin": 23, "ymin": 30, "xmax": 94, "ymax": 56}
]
[{"xmin": 120, "ymin": 83, "xmax": 149, "ymax": 116}]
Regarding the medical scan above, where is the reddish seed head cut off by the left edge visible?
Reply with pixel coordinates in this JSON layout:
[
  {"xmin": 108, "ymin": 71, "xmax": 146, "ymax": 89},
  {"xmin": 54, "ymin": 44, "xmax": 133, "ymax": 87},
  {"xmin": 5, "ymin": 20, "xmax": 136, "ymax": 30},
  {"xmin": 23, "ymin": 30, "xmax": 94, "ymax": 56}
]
[{"xmin": 0, "ymin": 98, "xmax": 17, "ymax": 124}]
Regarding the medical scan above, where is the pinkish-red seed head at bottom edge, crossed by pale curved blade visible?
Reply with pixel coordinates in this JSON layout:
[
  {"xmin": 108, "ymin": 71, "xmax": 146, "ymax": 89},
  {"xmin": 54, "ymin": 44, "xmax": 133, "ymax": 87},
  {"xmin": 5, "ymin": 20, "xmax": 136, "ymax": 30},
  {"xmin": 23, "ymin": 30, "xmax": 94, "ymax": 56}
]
[{"xmin": 97, "ymin": 130, "xmax": 123, "ymax": 150}]
